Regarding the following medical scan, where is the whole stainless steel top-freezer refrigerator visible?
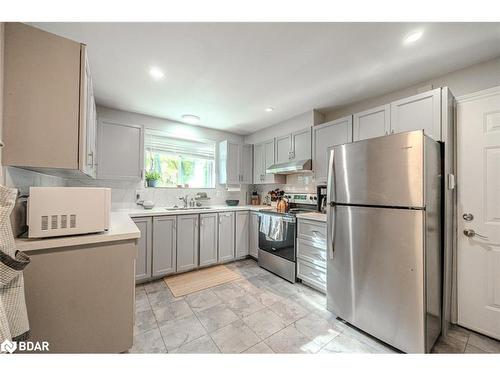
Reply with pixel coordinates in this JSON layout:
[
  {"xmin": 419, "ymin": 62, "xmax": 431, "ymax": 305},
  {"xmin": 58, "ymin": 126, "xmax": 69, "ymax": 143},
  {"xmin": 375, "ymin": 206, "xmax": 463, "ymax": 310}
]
[{"xmin": 327, "ymin": 131, "xmax": 442, "ymax": 353}]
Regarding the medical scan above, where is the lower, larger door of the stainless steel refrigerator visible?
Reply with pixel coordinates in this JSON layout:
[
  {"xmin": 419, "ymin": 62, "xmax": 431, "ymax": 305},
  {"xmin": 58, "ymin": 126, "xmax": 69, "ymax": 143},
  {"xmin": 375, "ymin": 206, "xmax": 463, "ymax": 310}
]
[{"xmin": 328, "ymin": 206, "xmax": 426, "ymax": 353}]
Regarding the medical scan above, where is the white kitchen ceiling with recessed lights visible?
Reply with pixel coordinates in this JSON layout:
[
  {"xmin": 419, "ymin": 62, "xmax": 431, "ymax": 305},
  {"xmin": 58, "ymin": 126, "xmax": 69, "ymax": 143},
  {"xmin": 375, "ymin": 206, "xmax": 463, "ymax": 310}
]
[{"xmin": 30, "ymin": 23, "xmax": 500, "ymax": 134}]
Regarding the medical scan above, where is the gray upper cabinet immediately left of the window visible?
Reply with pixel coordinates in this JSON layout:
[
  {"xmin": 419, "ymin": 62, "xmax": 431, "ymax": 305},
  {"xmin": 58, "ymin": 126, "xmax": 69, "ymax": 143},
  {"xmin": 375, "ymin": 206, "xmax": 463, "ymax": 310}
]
[{"xmin": 97, "ymin": 118, "xmax": 144, "ymax": 180}]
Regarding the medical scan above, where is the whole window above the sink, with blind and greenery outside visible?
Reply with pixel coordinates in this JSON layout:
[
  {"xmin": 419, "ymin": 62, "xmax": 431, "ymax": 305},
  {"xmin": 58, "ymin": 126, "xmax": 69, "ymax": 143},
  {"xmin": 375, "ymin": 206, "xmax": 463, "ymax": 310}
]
[{"xmin": 144, "ymin": 129, "xmax": 215, "ymax": 189}]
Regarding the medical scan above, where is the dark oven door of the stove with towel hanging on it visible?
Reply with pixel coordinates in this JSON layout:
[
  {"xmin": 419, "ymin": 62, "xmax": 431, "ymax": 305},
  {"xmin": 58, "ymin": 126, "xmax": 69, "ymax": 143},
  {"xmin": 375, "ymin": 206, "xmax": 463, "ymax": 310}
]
[{"xmin": 259, "ymin": 212, "xmax": 296, "ymax": 262}]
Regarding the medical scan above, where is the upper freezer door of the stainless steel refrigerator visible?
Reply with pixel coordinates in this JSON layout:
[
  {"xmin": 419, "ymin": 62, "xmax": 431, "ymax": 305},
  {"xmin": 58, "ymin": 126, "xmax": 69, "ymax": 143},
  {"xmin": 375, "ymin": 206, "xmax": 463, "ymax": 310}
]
[{"xmin": 329, "ymin": 131, "xmax": 424, "ymax": 207}]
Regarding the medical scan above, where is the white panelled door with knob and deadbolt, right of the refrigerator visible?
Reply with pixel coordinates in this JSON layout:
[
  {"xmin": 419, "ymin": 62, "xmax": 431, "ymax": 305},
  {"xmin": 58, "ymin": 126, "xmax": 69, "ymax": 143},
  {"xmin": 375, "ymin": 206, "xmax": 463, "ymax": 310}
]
[{"xmin": 457, "ymin": 87, "xmax": 500, "ymax": 339}]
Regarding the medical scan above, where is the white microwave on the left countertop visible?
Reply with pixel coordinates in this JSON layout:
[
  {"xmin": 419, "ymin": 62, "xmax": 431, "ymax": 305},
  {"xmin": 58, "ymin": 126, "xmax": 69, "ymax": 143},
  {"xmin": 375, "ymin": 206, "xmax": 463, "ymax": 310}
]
[{"xmin": 26, "ymin": 187, "xmax": 111, "ymax": 238}]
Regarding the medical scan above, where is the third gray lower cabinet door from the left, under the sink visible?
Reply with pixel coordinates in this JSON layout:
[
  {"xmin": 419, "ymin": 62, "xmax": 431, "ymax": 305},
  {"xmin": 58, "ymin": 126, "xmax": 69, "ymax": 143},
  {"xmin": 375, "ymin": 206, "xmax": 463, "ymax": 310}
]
[{"xmin": 177, "ymin": 215, "xmax": 198, "ymax": 272}]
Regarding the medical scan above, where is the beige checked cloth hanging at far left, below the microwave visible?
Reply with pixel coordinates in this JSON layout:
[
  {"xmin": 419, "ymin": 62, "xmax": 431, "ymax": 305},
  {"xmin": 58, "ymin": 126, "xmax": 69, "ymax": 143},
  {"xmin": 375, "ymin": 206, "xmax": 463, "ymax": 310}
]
[{"xmin": 0, "ymin": 185, "xmax": 30, "ymax": 342}]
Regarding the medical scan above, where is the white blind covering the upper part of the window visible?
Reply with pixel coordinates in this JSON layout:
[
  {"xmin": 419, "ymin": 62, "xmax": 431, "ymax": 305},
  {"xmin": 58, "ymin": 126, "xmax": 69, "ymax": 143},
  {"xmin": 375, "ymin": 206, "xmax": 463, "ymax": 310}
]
[{"xmin": 144, "ymin": 129, "xmax": 215, "ymax": 160}]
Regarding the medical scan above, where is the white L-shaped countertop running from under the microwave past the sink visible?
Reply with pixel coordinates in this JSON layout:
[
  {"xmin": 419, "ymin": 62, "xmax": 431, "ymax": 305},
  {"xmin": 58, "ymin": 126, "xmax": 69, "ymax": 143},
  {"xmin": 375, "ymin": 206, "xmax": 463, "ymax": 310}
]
[{"xmin": 16, "ymin": 205, "xmax": 271, "ymax": 252}]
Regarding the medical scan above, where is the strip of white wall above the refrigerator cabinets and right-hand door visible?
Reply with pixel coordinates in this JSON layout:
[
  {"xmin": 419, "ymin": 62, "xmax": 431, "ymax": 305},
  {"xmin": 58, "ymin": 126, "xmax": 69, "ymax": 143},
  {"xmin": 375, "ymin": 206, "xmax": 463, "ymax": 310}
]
[{"xmin": 322, "ymin": 57, "xmax": 500, "ymax": 121}]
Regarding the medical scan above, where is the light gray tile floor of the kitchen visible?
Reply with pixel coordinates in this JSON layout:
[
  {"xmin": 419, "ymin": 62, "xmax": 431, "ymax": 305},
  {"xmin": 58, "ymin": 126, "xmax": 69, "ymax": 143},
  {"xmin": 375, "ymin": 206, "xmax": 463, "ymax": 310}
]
[{"xmin": 129, "ymin": 259, "xmax": 500, "ymax": 353}]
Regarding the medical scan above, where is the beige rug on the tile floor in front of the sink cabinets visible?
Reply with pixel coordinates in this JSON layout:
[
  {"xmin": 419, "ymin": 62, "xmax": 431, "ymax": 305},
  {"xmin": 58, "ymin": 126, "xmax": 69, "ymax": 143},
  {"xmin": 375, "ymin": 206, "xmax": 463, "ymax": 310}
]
[{"xmin": 163, "ymin": 266, "xmax": 241, "ymax": 297}]
